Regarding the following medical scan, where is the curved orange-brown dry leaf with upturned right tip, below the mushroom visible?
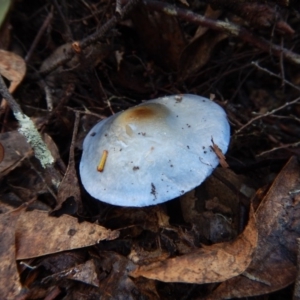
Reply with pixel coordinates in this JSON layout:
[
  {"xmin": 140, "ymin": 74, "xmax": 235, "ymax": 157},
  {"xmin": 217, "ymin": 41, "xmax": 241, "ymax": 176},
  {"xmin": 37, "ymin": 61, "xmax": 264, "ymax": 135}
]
[{"xmin": 130, "ymin": 205, "xmax": 257, "ymax": 284}]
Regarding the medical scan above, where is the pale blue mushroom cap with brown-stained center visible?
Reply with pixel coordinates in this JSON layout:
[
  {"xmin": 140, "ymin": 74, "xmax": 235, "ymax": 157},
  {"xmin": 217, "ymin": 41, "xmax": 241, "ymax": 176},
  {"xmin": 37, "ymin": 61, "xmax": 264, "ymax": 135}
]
[{"xmin": 80, "ymin": 95, "xmax": 230, "ymax": 207}]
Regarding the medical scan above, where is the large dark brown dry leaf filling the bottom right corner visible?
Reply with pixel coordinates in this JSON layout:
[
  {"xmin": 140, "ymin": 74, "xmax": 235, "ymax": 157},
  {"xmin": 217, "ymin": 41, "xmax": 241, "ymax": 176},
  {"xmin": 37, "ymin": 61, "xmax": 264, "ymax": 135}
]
[{"xmin": 206, "ymin": 157, "xmax": 300, "ymax": 300}]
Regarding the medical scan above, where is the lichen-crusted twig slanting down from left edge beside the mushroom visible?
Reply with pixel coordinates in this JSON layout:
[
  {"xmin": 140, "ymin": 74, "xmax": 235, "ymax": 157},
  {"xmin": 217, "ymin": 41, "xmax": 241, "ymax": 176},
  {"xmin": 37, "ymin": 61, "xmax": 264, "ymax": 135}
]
[{"xmin": 0, "ymin": 75, "xmax": 54, "ymax": 168}]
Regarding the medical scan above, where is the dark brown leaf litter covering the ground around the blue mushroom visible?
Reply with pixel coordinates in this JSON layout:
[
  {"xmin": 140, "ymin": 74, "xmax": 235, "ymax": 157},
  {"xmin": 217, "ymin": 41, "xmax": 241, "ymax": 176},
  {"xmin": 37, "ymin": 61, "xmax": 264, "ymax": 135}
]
[{"xmin": 0, "ymin": 0, "xmax": 300, "ymax": 299}]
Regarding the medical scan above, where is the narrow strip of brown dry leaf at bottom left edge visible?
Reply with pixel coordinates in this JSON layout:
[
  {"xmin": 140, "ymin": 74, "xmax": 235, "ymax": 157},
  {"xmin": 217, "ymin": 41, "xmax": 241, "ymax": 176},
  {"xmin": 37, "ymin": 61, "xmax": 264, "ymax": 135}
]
[{"xmin": 0, "ymin": 211, "xmax": 22, "ymax": 300}]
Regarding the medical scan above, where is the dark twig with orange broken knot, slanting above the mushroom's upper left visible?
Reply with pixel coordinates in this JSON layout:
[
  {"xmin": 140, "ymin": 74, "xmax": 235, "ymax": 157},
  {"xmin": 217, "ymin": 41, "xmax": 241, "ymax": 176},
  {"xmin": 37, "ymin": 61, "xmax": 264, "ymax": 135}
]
[{"xmin": 40, "ymin": 0, "xmax": 140, "ymax": 76}]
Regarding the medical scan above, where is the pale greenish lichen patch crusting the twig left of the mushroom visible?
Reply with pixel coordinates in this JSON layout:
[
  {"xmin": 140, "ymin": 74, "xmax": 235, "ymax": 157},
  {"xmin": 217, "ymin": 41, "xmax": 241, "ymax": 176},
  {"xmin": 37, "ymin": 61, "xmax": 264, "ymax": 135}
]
[{"xmin": 14, "ymin": 112, "xmax": 54, "ymax": 168}]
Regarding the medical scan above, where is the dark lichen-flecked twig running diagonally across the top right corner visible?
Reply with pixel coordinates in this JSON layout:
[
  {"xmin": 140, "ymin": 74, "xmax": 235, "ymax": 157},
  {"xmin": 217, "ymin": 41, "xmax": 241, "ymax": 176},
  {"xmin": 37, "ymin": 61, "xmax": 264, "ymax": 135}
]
[{"xmin": 135, "ymin": 0, "xmax": 300, "ymax": 64}]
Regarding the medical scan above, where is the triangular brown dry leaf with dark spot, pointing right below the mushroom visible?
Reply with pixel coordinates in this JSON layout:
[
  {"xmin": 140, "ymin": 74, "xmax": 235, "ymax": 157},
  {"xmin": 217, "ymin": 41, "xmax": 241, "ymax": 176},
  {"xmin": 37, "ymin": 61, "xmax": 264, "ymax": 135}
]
[{"xmin": 16, "ymin": 210, "xmax": 119, "ymax": 259}]
